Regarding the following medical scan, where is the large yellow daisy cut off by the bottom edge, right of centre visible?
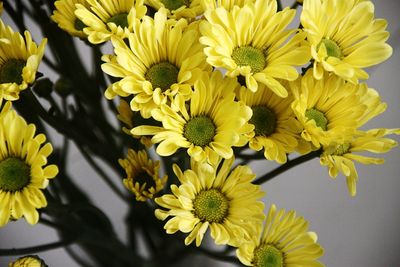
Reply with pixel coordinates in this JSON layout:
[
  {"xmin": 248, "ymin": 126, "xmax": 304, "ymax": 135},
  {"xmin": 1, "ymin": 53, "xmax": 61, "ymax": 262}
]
[{"xmin": 236, "ymin": 205, "xmax": 325, "ymax": 267}]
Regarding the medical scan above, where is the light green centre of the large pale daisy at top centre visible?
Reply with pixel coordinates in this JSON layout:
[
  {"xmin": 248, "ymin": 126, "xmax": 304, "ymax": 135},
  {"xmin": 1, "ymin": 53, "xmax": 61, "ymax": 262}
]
[{"xmin": 232, "ymin": 46, "xmax": 266, "ymax": 73}]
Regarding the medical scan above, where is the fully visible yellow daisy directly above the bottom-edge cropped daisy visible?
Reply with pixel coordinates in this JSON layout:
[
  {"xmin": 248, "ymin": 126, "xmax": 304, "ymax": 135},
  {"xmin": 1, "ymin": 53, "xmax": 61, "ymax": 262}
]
[{"xmin": 155, "ymin": 157, "xmax": 265, "ymax": 246}]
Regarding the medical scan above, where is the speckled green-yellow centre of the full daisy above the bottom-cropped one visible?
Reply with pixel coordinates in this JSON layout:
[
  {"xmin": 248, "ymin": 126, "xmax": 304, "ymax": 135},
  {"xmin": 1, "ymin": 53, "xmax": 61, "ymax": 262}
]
[{"xmin": 193, "ymin": 189, "xmax": 229, "ymax": 223}]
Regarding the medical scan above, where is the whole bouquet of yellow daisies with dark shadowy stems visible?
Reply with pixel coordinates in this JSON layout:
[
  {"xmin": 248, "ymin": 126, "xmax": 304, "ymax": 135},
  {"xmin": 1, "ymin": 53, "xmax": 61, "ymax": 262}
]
[{"xmin": 0, "ymin": 0, "xmax": 400, "ymax": 267}]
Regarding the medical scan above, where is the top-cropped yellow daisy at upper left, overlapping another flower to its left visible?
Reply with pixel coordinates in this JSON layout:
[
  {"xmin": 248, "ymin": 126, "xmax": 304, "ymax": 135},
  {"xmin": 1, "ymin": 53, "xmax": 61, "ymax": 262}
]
[{"xmin": 75, "ymin": 0, "xmax": 147, "ymax": 44}]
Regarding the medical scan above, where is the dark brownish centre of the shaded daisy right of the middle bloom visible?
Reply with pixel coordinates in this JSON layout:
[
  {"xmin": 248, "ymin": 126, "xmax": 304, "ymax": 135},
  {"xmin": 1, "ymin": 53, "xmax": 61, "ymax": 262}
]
[{"xmin": 249, "ymin": 106, "xmax": 276, "ymax": 136}]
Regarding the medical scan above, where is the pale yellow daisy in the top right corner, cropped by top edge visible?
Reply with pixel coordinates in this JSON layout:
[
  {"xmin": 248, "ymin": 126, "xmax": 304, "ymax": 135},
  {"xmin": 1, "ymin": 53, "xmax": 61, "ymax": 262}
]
[{"xmin": 301, "ymin": 0, "xmax": 392, "ymax": 83}]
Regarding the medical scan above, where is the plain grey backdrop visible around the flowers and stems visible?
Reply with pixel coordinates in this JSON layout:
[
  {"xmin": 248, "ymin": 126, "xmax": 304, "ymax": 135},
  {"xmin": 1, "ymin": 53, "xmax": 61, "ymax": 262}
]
[{"xmin": 0, "ymin": 0, "xmax": 400, "ymax": 267}]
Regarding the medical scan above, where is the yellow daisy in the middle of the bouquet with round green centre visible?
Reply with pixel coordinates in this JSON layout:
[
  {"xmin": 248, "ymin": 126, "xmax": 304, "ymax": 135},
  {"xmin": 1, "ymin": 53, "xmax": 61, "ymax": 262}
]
[{"xmin": 132, "ymin": 72, "xmax": 253, "ymax": 165}]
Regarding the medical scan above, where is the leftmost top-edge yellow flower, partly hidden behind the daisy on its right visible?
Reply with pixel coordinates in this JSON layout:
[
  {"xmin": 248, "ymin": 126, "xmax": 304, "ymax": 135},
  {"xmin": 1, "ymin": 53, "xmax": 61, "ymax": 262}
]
[{"xmin": 51, "ymin": 0, "xmax": 88, "ymax": 38}]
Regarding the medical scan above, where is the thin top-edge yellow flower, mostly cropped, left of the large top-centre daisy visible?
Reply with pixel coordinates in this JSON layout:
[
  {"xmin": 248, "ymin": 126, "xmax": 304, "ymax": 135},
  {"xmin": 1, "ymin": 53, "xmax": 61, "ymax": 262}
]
[{"xmin": 145, "ymin": 0, "xmax": 203, "ymax": 19}]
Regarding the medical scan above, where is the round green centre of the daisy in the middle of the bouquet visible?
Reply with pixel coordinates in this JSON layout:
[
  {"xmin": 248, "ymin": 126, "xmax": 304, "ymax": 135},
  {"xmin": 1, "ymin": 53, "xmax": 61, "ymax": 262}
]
[{"xmin": 183, "ymin": 116, "xmax": 215, "ymax": 146}]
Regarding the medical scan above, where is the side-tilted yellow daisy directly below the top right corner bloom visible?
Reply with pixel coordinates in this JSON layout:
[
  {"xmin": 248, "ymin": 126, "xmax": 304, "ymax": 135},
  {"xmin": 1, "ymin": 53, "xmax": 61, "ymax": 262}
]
[{"xmin": 291, "ymin": 70, "xmax": 386, "ymax": 148}]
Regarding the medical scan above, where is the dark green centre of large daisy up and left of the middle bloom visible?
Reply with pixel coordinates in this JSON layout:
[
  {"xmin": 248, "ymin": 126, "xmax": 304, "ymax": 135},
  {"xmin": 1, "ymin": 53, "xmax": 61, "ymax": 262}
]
[{"xmin": 145, "ymin": 62, "xmax": 179, "ymax": 91}]
